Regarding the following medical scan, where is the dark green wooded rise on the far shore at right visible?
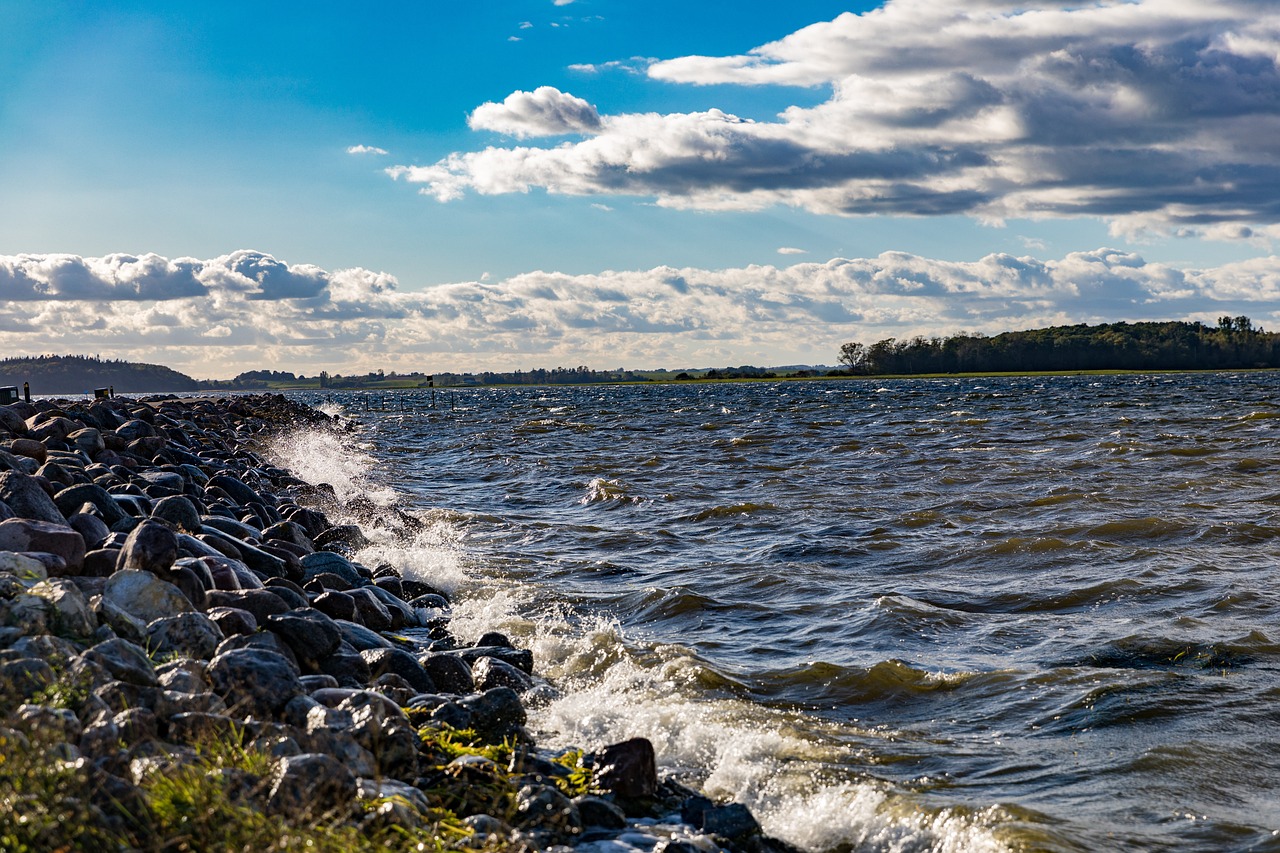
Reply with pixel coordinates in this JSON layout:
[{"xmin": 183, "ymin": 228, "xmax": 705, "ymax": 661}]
[{"xmin": 840, "ymin": 316, "xmax": 1280, "ymax": 375}]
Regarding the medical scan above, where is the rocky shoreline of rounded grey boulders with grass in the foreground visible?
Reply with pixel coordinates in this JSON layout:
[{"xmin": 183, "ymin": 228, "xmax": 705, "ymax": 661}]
[{"xmin": 0, "ymin": 396, "xmax": 790, "ymax": 853}]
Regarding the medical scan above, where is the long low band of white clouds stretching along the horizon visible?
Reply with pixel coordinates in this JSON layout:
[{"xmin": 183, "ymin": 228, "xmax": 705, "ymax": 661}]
[{"xmin": 0, "ymin": 248, "xmax": 1280, "ymax": 378}]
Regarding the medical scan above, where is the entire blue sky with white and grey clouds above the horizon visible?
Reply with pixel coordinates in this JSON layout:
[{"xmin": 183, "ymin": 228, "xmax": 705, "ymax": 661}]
[{"xmin": 0, "ymin": 0, "xmax": 1280, "ymax": 378}]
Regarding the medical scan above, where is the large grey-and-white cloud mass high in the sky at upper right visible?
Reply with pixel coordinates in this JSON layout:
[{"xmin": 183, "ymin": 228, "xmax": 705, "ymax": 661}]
[{"xmin": 389, "ymin": 0, "xmax": 1280, "ymax": 234}]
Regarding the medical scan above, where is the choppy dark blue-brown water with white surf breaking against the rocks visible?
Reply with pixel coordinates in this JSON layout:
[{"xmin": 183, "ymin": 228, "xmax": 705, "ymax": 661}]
[{"xmin": 280, "ymin": 373, "xmax": 1280, "ymax": 850}]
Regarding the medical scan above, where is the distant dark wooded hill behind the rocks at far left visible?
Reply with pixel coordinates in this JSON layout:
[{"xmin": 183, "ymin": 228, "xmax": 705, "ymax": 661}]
[{"xmin": 0, "ymin": 355, "xmax": 200, "ymax": 394}]
